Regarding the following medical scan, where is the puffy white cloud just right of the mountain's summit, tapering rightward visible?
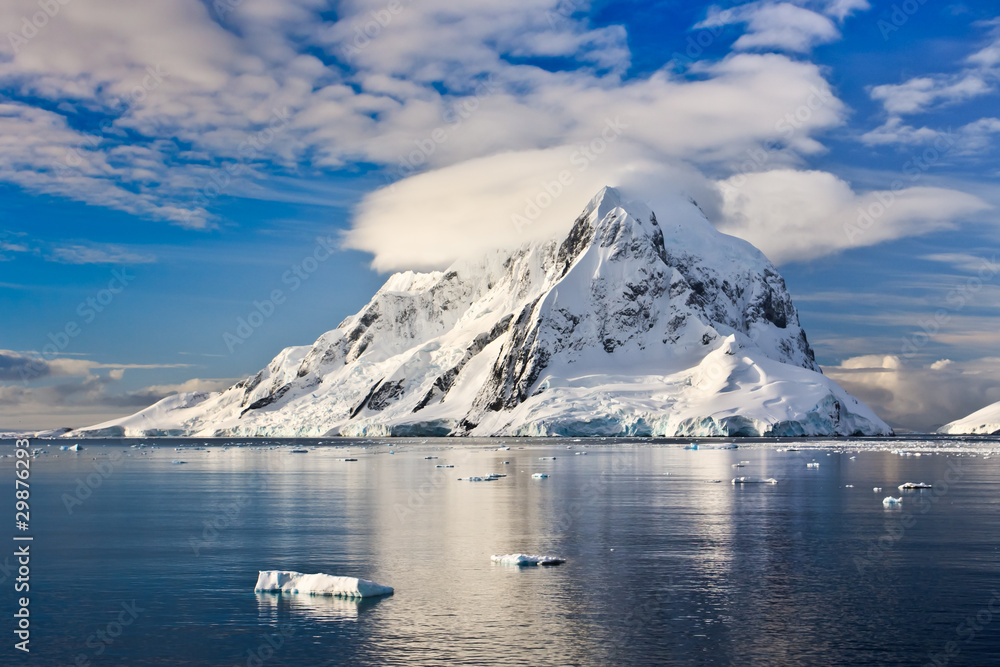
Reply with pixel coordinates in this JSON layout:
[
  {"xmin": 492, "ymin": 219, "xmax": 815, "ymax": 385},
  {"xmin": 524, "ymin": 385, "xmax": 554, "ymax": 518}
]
[{"xmin": 719, "ymin": 169, "xmax": 990, "ymax": 263}]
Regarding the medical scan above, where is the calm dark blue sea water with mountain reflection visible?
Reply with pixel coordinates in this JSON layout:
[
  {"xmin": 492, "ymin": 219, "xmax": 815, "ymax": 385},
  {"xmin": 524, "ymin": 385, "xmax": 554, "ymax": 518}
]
[{"xmin": 0, "ymin": 439, "xmax": 1000, "ymax": 666}]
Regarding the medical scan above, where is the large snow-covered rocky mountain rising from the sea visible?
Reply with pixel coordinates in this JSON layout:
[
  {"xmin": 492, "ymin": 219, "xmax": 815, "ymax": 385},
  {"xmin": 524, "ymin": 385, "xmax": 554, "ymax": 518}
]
[{"xmin": 74, "ymin": 188, "xmax": 891, "ymax": 436}]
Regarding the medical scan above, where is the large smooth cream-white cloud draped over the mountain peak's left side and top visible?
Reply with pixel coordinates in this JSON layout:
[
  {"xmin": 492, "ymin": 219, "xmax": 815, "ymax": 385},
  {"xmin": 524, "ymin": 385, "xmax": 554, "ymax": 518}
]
[{"xmin": 345, "ymin": 144, "xmax": 705, "ymax": 271}]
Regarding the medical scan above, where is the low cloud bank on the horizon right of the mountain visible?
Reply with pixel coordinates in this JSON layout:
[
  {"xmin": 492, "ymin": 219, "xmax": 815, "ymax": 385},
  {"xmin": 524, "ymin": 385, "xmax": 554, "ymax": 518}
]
[{"xmin": 823, "ymin": 355, "xmax": 1000, "ymax": 431}]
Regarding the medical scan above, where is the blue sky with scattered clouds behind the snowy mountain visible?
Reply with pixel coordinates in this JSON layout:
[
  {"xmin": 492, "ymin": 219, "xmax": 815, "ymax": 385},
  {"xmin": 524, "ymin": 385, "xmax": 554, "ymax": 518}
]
[{"xmin": 0, "ymin": 0, "xmax": 1000, "ymax": 429}]
